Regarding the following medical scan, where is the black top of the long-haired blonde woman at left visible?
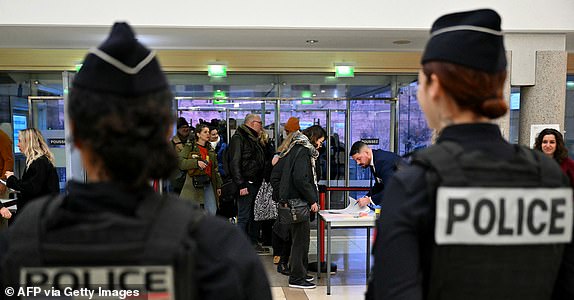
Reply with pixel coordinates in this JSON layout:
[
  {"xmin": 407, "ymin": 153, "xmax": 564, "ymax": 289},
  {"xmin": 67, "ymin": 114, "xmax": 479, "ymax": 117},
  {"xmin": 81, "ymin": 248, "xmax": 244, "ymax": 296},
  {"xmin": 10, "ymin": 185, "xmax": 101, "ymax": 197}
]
[{"xmin": 6, "ymin": 156, "xmax": 60, "ymax": 211}]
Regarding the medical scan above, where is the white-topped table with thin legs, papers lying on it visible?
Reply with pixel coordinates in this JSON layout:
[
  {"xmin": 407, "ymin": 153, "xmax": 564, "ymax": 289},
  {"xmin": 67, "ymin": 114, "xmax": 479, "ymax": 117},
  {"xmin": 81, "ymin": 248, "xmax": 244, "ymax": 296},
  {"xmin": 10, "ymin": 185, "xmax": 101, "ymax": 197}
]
[{"xmin": 317, "ymin": 210, "xmax": 376, "ymax": 295}]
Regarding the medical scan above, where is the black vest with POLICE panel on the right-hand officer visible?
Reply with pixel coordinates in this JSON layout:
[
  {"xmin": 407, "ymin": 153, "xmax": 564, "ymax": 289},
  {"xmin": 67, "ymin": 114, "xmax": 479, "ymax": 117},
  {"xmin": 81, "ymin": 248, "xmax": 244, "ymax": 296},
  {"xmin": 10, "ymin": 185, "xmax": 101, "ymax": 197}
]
[{"xmin": 412, "ymin": 141, "xmax": 572, "ymax": 299}]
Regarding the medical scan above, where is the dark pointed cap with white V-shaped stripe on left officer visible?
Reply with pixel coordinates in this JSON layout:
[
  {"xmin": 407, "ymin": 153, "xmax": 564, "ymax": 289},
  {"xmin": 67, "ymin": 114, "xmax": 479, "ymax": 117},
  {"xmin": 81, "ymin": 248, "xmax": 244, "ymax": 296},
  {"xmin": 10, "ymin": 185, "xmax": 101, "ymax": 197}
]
[{"xmin": 73, "ymin": 23, "xmax": 168, "ymax": 96}]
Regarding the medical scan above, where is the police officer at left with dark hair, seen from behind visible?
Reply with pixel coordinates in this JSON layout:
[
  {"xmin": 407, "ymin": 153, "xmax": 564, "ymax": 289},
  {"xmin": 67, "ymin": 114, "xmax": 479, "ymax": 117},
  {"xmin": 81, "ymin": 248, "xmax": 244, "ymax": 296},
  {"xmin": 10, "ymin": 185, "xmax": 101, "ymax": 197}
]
[{"xmin": 0, "ymin": 23, "xmax": 271, "ymax": 299}]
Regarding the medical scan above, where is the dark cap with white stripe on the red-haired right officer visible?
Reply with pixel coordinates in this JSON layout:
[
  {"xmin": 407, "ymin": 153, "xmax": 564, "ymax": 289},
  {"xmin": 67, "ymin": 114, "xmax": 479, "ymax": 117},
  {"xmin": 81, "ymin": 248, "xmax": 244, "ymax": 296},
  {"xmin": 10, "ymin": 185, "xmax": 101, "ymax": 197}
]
[{"xmin": 421, "ymin": 9, "xmax": 506, "ymax": 73}]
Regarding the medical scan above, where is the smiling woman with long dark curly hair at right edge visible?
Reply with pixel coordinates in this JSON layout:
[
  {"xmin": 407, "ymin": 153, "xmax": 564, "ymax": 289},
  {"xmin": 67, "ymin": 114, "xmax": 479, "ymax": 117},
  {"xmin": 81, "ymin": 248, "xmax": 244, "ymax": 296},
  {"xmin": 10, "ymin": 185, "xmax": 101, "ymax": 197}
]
[{"xmin": 534, "ymin": 128, "xmax": 574, "ymax": 187}]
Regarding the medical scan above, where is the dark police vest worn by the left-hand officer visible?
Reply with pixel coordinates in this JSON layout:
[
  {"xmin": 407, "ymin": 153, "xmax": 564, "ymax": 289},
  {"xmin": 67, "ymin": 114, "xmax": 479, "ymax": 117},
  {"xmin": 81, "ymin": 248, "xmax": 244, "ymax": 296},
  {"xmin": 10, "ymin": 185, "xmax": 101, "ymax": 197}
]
[{"xmin": 2, "ymin": 194, "xmax": 203, "ymax": 299}]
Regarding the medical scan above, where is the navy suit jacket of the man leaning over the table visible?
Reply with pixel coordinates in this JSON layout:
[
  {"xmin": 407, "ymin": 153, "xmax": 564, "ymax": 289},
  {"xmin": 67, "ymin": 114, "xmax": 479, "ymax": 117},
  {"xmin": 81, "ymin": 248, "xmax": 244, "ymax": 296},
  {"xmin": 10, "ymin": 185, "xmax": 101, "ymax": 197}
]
[{"xmin": 367, "ymin": 150, "xmax": 401, "ymax": 205}]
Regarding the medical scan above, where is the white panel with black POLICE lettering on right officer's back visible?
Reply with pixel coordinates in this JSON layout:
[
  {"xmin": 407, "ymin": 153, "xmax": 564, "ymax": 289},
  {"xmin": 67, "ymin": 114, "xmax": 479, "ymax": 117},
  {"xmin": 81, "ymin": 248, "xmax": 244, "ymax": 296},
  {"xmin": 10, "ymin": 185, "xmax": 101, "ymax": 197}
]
[{"xmin": 435, "ymin": 187, "xmax": 574, "ymax": 245}]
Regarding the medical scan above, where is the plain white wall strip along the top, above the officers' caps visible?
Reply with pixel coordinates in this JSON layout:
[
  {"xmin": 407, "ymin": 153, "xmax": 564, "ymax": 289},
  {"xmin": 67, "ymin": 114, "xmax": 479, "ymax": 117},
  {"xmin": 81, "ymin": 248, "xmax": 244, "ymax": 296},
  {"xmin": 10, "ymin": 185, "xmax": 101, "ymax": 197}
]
[{"xmin": 0, "ymin": 0, "xmax": 574, "ymax": 30}]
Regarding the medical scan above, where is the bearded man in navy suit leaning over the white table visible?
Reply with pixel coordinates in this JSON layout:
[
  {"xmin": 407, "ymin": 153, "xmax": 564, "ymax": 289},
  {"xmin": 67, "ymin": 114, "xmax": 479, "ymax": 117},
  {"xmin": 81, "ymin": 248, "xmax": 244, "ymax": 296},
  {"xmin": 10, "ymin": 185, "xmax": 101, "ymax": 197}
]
[{"xmin": 350, "ymin": 141, "xmax": 401, "ymax": 207}]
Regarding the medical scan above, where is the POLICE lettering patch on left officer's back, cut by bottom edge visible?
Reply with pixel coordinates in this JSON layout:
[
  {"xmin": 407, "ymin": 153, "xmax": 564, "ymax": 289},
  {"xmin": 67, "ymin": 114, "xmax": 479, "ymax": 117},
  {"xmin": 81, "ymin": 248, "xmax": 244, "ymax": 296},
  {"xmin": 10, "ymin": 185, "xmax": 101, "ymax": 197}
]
[{"xmin": 20, "ymin": 266, "xmax": 175, "ymax": 299}]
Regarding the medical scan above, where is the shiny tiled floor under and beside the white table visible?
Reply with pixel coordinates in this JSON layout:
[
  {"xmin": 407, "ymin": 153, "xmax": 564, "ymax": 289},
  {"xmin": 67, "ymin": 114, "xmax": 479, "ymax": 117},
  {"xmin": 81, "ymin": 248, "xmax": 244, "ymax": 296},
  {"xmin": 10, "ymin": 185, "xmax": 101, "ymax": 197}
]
[{"xmin": 260, "ymin": 229, "xmax": 372, "ymax": 300}]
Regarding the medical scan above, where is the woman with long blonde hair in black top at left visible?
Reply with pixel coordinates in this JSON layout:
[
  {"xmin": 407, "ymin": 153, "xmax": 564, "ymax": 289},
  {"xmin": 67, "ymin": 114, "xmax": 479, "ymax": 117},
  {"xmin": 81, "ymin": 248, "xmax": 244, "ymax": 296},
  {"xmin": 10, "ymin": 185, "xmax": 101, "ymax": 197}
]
[{"xmin": 5, "ymin": 128, "xmax": 60, "ymax": 211}]
